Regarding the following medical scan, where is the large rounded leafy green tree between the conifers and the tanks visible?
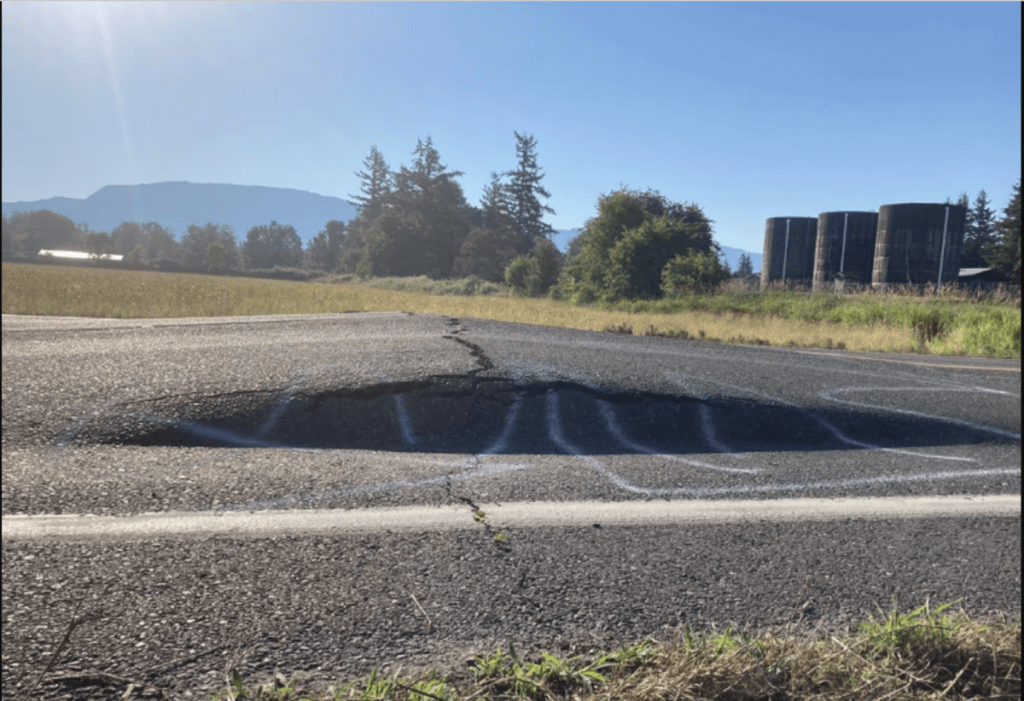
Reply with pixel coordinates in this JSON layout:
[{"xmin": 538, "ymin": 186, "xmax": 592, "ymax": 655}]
[{"xmin": 555, "ymin": 188, "xmax": 721, "ymax": 303}]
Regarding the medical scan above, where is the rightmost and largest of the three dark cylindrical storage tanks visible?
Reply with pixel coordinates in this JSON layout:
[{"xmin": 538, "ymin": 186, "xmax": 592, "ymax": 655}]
[{"xmin": 871, "ymin": 204, "xmax": 967, "ymax": 287}]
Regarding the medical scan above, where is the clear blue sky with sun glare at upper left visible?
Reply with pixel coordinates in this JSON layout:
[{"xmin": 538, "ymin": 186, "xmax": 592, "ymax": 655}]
[{"xmin": 2, "ymin": 1, "xmax": 1021, "ymax": 252}]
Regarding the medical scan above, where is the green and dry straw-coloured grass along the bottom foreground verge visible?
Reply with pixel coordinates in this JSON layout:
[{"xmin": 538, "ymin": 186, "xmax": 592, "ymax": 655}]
[{"xmin": 207, "ymin": 604, "xmax": 1021, "ymax": 701}]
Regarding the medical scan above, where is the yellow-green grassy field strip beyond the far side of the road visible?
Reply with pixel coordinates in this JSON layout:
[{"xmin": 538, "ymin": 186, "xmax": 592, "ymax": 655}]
[{"xmin": 3, "ymin": 264, "xmax": 1021, "ymax": 357}]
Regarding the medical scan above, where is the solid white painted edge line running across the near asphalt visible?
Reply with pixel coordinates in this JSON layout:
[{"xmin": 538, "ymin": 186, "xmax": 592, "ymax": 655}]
[{"xmin": 2, "ymin": 494, "xmax": 1021, "ymax": 541}]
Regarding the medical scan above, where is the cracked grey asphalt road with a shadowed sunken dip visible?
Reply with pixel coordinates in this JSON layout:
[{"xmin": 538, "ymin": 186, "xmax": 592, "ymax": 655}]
[{"xmin": 2, "ymin": 313, "xmax": 1021, "ymax": 697}]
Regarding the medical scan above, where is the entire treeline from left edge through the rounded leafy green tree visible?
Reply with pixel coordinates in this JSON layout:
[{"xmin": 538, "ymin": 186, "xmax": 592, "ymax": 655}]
[{"xmin": 3, "ymin": 132, "xmax": 728, "ymax": 302}]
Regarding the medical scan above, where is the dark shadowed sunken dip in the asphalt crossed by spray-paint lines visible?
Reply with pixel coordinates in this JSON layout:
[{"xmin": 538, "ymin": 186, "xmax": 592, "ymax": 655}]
[{"xmin": 61, "ymin": 377, "xmax": 1015, "ymax": 455}]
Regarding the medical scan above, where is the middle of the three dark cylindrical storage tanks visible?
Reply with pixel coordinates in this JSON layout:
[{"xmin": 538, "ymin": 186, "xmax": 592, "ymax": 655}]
[{"xmin": 814, "ymin": 212, "xmax": 879, "ymax": 290}]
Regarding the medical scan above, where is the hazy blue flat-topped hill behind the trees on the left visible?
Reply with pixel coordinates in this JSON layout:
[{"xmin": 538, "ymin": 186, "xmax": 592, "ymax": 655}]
[{"xmin": 3, "ymin": 182, "xmax": 357, "ymax": 243}]
